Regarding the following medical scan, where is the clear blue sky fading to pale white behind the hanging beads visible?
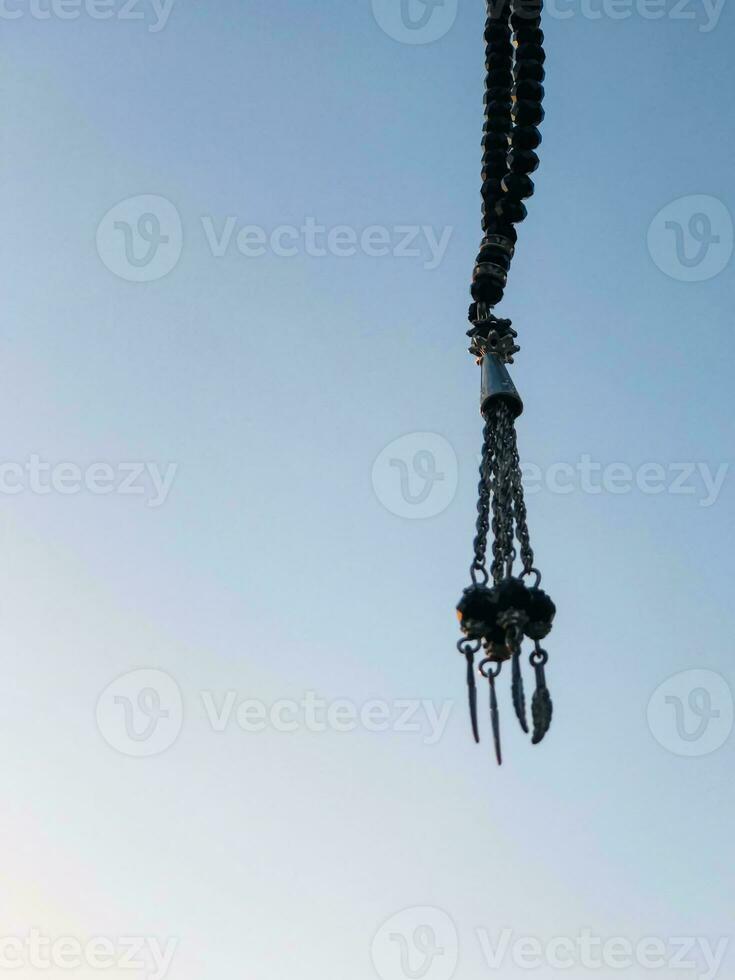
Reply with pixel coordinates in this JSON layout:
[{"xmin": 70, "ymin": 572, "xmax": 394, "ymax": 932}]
[{"xmin": 0, "ymin": 0, "xmax": 735, "ymax": 980}]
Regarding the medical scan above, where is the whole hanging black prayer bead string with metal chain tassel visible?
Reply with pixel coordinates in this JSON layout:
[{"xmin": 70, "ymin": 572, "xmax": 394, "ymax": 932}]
[{"xmin": 457, "ymin": 0, "xmax": 556, "ymax": 764}]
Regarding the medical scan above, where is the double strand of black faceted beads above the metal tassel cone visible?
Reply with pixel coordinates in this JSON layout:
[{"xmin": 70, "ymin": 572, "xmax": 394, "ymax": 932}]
[{"xmin": 469, "ymin": 0, "xmax": 546, "ymax": 332}]
